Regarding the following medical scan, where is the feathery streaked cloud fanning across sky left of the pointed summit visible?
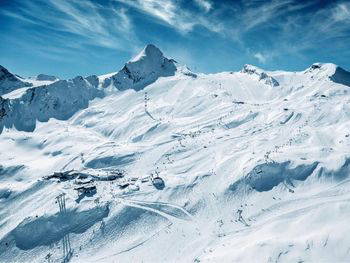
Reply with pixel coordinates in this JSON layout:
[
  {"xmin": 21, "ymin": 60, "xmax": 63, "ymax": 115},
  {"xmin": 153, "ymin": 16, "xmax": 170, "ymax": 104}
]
[{"xmin": 1, "ymin": 0, "xmax": 138, "ymax": 50}]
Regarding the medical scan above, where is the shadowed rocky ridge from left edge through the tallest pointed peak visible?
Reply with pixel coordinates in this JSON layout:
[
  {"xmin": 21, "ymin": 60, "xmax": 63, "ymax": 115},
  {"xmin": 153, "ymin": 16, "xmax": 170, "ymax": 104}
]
[{"xmin": 0, "ymin": 45, "xmax": 191, "ymax": 133}]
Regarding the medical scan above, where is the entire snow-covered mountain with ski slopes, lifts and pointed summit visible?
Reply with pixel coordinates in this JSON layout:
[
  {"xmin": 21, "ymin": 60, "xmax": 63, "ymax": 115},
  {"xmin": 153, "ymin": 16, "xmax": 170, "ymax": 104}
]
[{"xmin": 0, "ymin": 45, "xmax": 350, "ymax": 262}]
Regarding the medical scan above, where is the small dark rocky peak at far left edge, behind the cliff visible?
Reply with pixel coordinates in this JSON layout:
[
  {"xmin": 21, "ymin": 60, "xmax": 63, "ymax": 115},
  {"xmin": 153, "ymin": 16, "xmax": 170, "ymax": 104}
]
[{"xmin": 0, "ymin": 65, "xmax": 32, "ymax": 96}]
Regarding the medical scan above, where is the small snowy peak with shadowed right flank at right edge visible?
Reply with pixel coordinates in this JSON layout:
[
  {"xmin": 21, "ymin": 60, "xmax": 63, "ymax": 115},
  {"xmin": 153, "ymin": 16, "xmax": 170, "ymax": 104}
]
[{"xmin": 304, "ymin": 63, "xmax": 350, "ymax": 87}]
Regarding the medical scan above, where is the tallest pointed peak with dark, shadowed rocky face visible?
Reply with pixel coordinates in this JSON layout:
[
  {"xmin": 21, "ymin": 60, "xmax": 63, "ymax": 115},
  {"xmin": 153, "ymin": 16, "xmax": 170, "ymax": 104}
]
[{"xmin": 103, "ymin": 45, "xmax": 177, "ymax": 90}]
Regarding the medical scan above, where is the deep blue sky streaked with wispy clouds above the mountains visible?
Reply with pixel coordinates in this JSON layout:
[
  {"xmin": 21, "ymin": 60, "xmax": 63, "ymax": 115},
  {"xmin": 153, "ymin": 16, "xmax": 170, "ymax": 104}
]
[{"xmin": 0, "ymin": 0, "xmax": 350, "ymax": 78}]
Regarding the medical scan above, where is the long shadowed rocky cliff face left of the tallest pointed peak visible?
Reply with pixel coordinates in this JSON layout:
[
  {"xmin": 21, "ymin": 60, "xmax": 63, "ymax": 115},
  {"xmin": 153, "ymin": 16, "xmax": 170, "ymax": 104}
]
[{"xmin": 0, "ymin": 76, "xmax": 104, "ymax": 134}]
